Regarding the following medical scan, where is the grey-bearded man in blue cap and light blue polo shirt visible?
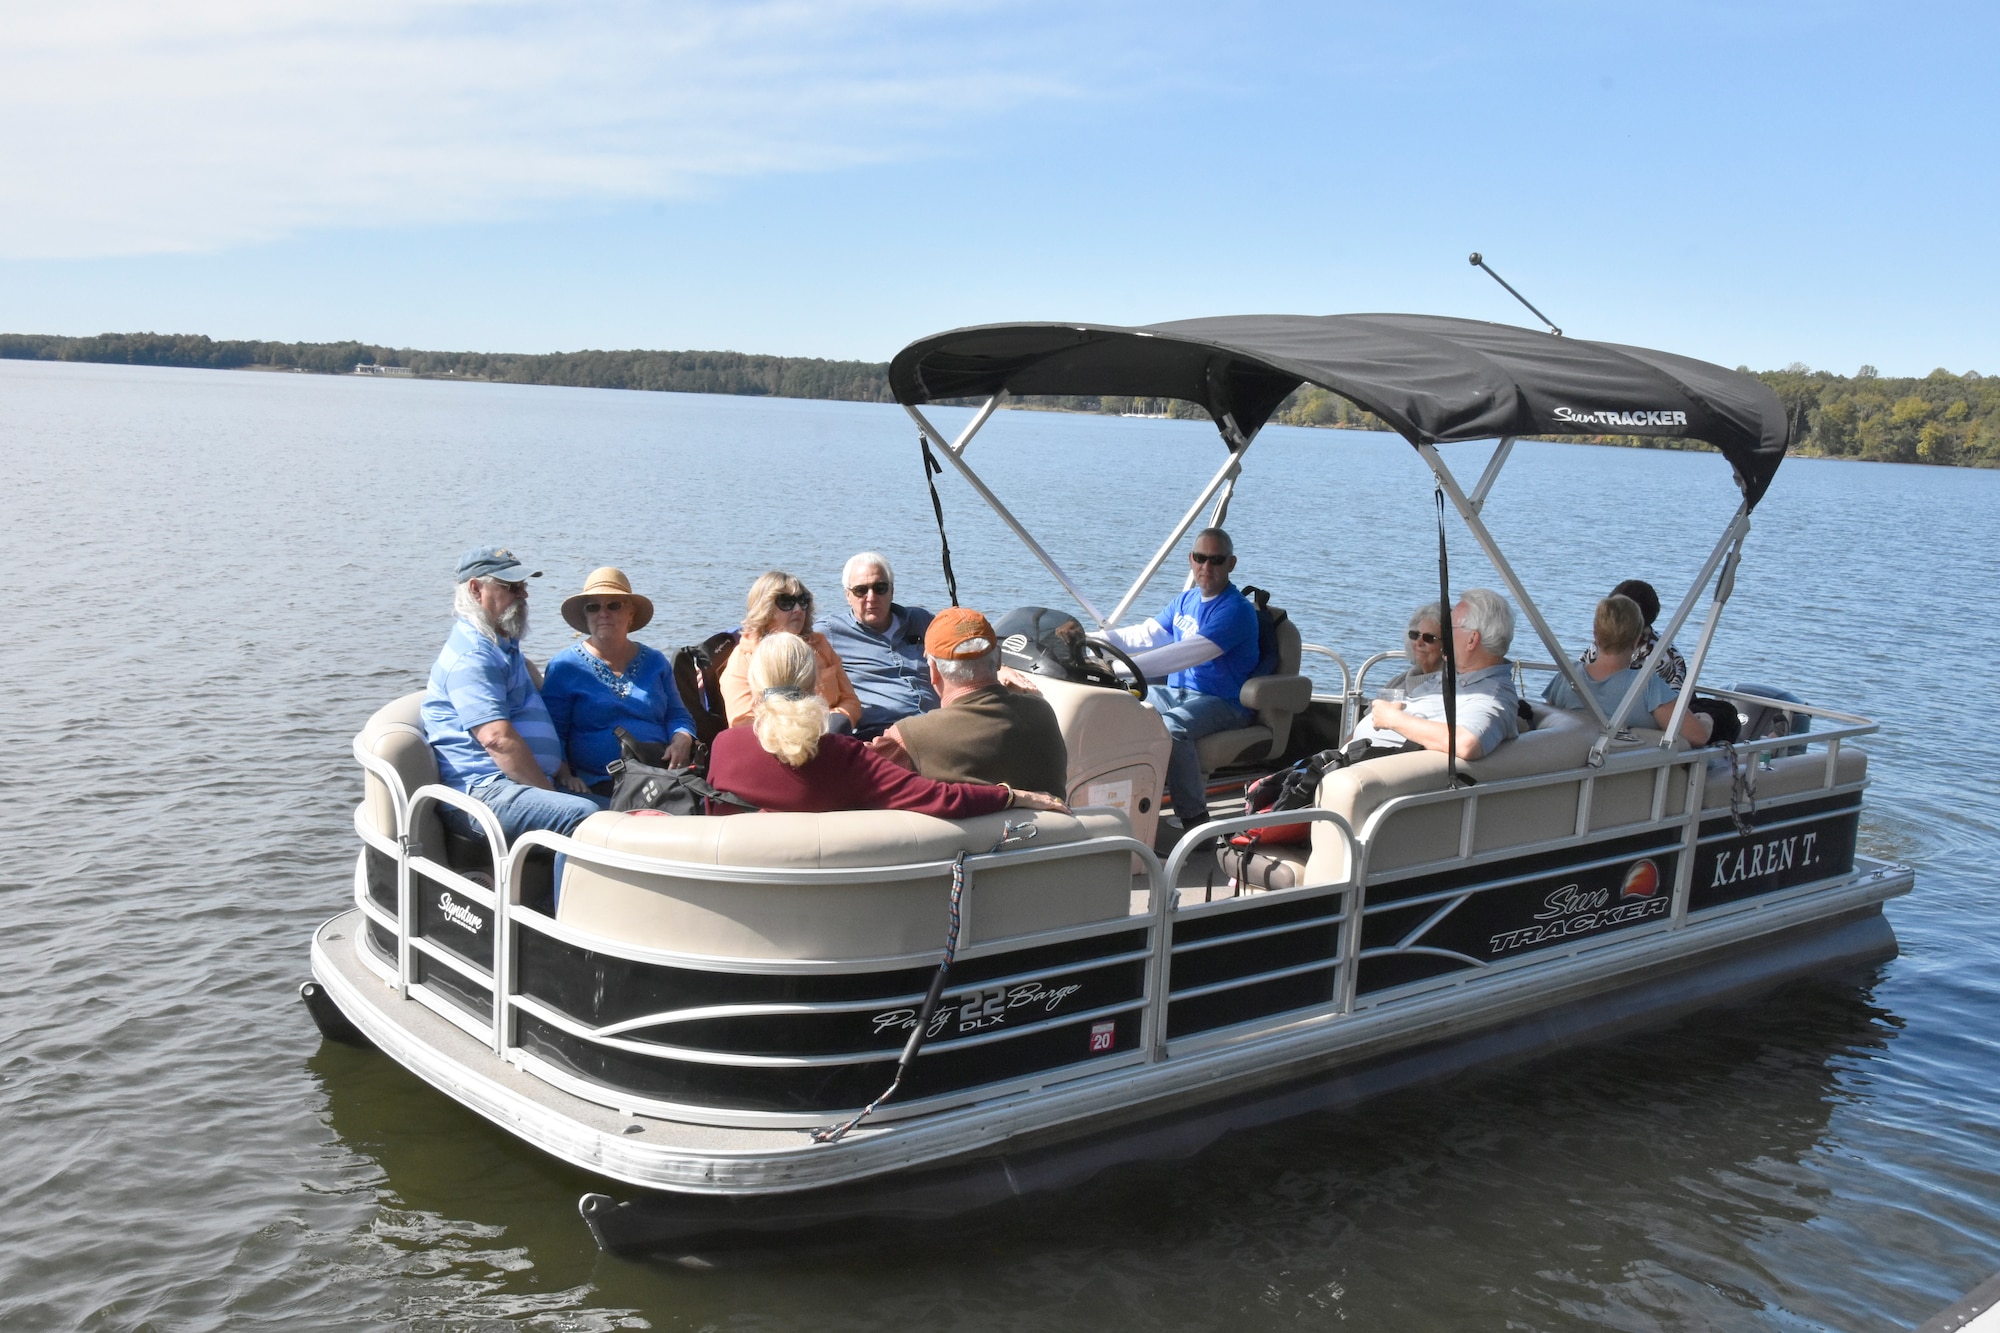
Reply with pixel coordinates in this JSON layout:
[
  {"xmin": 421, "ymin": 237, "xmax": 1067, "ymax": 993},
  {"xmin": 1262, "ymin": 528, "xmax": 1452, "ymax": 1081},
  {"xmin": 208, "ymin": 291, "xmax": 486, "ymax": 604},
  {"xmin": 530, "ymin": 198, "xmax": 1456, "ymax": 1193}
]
[{"xmin": 424, "ymin": 546, "xmax": 604, "ymax": 843}]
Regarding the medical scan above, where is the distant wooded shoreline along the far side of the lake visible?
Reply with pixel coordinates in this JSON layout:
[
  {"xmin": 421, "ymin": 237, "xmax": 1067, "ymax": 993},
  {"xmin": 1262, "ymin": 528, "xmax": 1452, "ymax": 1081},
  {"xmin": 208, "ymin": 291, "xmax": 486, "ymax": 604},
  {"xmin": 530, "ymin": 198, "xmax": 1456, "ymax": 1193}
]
[{"xmin": 0, "ymin": 332, "xmax": 2000, "ymax": 468}]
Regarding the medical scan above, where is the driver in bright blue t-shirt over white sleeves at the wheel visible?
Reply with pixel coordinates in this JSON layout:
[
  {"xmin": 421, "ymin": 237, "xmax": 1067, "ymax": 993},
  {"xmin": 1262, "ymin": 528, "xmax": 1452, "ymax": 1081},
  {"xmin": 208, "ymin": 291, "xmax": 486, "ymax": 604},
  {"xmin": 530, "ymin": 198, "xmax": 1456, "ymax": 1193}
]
[{"xmin": 1108, "ymin": 528, "xmax": 1258, "ymax": 829}]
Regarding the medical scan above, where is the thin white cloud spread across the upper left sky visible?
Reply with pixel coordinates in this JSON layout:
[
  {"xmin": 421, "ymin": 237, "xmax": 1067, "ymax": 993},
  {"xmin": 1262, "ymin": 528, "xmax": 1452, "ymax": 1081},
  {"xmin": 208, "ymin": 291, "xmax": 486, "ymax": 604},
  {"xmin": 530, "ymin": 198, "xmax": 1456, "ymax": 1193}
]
[{"xmin": 0, "ymin": 0, "xmax": 1092, "ymax": 258}]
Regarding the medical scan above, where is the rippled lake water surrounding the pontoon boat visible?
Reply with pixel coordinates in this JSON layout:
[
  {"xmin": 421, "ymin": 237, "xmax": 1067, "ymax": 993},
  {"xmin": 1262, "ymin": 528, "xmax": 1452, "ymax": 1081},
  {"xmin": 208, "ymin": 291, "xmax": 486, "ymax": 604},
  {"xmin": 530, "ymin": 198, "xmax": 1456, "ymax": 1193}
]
[{"xmin": 0, "ymin": 362, "xmax": 2000, "ymax": 1333}]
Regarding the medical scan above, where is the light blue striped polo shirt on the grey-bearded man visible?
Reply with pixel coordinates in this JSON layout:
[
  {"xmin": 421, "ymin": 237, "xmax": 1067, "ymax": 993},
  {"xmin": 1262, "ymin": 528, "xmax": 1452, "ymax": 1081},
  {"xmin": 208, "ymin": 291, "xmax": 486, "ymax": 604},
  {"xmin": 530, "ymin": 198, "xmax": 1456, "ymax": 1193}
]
[{"xmin": 424, "ymin": 620, "xmax": 562, "ymax": 791}]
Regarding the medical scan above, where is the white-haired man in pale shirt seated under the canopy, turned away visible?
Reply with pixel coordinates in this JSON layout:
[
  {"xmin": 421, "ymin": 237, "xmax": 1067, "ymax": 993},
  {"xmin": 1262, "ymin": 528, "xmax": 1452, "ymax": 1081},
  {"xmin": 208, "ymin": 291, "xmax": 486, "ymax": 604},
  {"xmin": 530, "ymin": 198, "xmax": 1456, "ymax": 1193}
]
[{"xmin": 1344, "ymin": 588, "xmax": 1520, "ymax": 765}]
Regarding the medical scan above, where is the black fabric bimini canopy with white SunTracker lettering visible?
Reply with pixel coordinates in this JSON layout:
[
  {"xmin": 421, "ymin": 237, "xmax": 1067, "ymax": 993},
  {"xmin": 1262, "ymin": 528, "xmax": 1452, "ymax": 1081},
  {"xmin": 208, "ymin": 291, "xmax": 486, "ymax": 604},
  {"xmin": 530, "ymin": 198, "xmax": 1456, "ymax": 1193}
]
[{"xmin": 888, "ymin": 314, "xmax": 1790, "ymax": 504}]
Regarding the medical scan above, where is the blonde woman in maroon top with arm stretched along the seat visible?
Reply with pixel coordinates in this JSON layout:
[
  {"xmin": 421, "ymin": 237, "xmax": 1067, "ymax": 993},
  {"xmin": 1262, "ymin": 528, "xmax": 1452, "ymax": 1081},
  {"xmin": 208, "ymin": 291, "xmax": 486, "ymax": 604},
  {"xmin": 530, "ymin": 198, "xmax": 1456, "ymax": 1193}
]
[{"xmin": 708, "ymin": 632, "xmax": 1070, "ymax": 819}]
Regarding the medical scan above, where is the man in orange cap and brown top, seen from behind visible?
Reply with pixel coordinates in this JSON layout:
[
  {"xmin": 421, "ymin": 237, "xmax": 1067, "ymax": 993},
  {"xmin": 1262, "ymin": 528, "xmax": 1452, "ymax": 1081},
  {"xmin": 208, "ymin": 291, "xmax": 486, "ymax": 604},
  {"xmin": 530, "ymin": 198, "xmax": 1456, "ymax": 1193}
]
[{"xmin": 872, "ymin": 606, "xmax": 1070, "ymax": 801}]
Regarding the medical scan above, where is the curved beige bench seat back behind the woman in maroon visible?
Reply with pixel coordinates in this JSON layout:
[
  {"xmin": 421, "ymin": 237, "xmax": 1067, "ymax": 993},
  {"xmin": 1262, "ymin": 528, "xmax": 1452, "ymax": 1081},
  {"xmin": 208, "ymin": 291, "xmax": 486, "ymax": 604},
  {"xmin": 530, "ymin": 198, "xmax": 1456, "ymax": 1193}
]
[{"xmin": 556, "ymin": 807, "xmax": 1132, "ymax": 961}]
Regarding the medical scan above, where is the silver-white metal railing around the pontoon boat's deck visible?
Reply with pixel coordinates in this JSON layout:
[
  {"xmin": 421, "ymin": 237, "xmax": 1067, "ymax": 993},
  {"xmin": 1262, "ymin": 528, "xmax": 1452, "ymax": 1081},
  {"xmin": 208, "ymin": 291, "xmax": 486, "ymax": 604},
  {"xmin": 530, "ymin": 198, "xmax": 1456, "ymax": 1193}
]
[{"xmin": 356, "ymin": 680, "xmax": 1878, "ymax": 1125}]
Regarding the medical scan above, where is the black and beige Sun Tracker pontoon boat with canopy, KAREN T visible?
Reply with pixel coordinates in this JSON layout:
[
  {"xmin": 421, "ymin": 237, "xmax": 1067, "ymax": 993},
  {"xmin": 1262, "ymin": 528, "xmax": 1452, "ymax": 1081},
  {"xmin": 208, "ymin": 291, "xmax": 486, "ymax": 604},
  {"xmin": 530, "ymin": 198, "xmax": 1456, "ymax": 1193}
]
[{"xmin": 306, "ymin": 316, "xmax": 1912, "ymax": 1249}]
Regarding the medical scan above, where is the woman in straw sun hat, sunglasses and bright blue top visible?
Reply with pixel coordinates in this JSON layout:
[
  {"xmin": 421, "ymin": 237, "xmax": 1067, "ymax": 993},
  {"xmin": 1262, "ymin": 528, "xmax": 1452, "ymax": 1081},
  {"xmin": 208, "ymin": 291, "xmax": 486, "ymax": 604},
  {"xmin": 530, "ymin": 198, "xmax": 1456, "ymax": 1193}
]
[{"xmin": 542, "ymin": 566, "xmax": 694, "ymax": 797}]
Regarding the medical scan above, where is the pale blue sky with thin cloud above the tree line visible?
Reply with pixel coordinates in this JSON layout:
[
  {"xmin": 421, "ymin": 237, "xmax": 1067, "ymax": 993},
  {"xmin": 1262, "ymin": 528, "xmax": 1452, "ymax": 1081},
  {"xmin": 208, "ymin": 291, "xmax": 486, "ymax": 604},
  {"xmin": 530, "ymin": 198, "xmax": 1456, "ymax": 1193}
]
[{"xmin": 0, "ymin": 0, "xmax": 2000, "ymax": 374}]
